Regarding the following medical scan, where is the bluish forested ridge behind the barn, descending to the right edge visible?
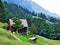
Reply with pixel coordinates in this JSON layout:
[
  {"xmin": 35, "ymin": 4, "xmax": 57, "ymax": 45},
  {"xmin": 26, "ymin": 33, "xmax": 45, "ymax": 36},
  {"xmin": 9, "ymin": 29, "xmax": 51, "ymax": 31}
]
[{"xmin": 3, "ymin": 1, "xmax": 60, "ymax": 23}]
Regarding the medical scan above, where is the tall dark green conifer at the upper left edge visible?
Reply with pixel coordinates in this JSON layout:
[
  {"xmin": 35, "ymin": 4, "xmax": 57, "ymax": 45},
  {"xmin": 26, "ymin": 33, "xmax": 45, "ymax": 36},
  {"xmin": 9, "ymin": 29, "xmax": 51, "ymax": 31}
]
[{"xmin": 0, "ymin": 0, "xmax": 9, "ymax": 22}]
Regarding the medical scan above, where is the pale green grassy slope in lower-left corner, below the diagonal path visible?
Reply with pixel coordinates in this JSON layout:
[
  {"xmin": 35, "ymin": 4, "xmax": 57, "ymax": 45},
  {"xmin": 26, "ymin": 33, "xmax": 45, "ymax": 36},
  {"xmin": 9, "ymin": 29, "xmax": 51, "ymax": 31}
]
[{"xmin": 0, "ymin": 28, "xmax": 24, "ymax": 45}]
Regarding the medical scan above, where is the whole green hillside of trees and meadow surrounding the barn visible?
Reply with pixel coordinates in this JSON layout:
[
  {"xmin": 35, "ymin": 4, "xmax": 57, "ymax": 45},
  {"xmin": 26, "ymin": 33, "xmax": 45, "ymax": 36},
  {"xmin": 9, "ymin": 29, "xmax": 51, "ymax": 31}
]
[{"xmin": 0, "ymin": 1, "xmax": 60, "ymax": 45}]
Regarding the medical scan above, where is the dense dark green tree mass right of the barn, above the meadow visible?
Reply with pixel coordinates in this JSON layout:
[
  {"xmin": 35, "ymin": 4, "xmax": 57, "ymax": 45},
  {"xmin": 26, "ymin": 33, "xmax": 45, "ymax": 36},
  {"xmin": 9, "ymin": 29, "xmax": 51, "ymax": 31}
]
[{"xmin": 27, "ymin": 14, "xmax": 57, "ymax": 39}]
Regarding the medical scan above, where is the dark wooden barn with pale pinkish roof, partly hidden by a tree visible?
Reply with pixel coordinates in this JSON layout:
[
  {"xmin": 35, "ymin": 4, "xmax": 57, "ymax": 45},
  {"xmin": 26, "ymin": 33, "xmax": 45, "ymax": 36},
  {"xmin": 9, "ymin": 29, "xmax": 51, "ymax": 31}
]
[{"xmin": 8, "ymin": 19, "xmax": 28, "ymax": 34}]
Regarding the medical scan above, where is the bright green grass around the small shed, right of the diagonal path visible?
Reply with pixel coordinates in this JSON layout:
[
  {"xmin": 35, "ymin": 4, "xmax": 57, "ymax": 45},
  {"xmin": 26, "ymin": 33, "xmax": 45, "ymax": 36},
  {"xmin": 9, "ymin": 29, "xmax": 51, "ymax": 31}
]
[{"xmin": 15, "ymin": 34, "xmax": 60, "ymax": 45}]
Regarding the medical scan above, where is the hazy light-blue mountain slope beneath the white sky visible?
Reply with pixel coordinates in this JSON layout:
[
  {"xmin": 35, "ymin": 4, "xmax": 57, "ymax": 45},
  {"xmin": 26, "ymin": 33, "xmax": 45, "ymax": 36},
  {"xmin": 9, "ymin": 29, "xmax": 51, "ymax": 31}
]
[{"xmin": 2, "ymin": 0, "xmax": 60, "ymax": 19}]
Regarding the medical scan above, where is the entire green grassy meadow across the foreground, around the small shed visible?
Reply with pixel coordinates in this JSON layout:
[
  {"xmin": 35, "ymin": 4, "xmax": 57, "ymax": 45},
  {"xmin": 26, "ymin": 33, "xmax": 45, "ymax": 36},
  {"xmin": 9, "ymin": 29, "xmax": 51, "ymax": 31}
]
[{"xmin": 0, "ymin": 28, "xmax": 60, "ymax": 45}]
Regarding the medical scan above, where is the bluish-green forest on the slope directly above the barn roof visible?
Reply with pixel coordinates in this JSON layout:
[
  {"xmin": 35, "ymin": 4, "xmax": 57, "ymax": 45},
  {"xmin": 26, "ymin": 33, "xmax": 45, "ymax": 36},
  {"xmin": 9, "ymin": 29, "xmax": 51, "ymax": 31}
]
[{"xmin": 4, "ymin": 2, "xmax": 31, "ymax": 18}]
